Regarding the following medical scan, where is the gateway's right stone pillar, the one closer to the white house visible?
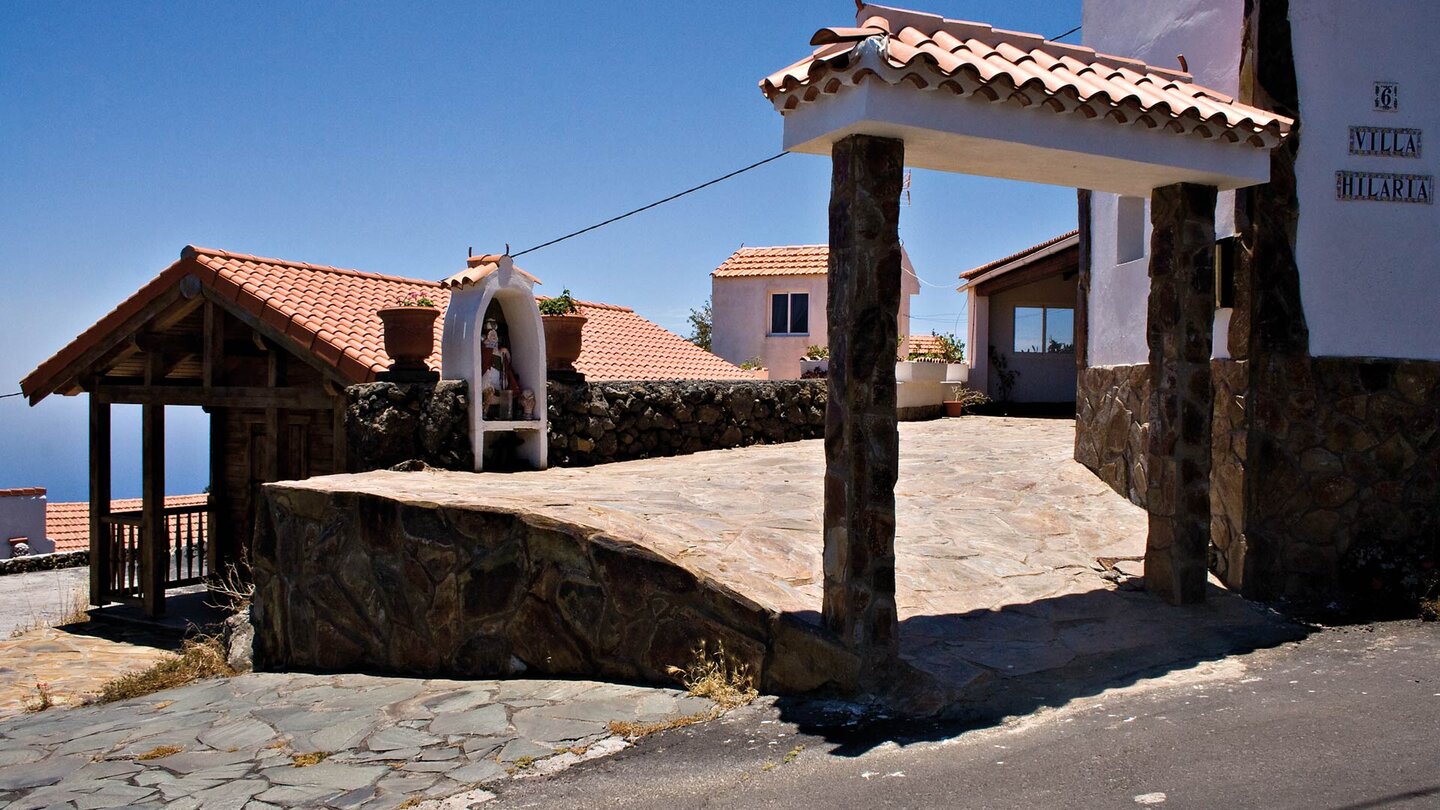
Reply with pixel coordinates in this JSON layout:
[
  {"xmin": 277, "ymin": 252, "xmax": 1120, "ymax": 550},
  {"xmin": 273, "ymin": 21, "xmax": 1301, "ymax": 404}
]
[{"xmin": 1145, "ymin": 183, "xmax": 1215, "ymax": 604}]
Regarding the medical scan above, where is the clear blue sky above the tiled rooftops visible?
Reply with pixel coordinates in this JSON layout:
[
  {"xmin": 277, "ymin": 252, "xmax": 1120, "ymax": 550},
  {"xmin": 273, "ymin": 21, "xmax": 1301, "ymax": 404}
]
[{"xmin": 0, "ymin": 0, "xmax": 1080, "ymax": 500}]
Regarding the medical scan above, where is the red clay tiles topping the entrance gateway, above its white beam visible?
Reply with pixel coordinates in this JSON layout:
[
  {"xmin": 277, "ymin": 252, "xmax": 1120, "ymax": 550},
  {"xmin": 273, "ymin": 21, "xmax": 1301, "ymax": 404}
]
[{"xmin": 760, "ymin": 4, "xmax": 1293, "ymax": 148}]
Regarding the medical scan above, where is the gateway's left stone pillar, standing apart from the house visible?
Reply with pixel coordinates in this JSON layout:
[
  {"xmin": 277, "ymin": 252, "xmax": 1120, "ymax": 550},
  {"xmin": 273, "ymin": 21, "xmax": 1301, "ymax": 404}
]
[{"xmin": 824, "ymin": 135, "xmax": 904, "ymax": 686}]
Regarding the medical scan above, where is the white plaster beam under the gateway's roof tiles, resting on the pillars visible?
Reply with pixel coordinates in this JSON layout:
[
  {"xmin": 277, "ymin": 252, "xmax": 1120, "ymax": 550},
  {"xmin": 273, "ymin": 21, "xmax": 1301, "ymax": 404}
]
[{"xmin": 785, "ymin": 79, "xmax": 1270, "ymax": 197}]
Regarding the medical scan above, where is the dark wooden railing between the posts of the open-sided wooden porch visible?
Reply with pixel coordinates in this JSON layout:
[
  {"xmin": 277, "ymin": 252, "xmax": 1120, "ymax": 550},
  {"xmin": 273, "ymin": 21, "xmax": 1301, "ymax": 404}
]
[{"xmin": 101, "ymin": 503, "xmax": 210, "ymax": 601}]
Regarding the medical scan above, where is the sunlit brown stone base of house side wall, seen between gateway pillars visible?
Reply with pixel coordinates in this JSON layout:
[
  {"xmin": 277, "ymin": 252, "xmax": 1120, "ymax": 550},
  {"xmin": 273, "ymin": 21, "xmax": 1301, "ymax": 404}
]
[{"xmin": 1076, "ymin": 363, "xmax": 1151, "ymax": 506}]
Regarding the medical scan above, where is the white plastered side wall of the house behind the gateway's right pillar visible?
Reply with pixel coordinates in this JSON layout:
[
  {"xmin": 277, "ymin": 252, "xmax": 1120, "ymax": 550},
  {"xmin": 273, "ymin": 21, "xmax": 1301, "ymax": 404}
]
[{"xmin": 1083, "ymin": 0, "xmax": 1244, "ymax": 366}]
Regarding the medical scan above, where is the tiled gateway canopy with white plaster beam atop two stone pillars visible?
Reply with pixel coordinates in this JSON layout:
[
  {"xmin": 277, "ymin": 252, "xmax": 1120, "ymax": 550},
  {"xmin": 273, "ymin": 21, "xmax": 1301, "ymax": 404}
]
[{"xmin": 760, "ymin": 3, "xmax": 1293, "ymax": 196}]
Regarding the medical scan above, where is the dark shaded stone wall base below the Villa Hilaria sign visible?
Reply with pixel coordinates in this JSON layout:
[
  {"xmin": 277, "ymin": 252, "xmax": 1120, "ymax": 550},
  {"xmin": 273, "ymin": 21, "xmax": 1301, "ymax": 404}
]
[{"xmin": 1244, "ymin": 357, "xmax": 1440, "ymax": 614}]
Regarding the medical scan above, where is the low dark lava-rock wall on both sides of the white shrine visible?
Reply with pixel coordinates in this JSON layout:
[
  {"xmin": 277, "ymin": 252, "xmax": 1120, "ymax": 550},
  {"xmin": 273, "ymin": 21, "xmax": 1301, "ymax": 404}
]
[{"xmin": 346, "ymin": 379, "xmax": 825, "ymax": 471}]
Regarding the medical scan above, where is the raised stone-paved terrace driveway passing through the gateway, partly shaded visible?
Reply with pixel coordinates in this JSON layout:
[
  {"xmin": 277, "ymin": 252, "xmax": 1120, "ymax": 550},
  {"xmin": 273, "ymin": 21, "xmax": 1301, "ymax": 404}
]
[{"xmin": 275, "ymin": 417, "xmax": 1301, "ymax": 693}]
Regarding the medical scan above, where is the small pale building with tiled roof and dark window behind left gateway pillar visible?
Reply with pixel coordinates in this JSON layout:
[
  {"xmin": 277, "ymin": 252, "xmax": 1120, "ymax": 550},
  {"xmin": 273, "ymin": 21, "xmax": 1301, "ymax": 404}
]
[{"xmin": 710, "ymin": 245, "xmax": 920, "ymax": 379}]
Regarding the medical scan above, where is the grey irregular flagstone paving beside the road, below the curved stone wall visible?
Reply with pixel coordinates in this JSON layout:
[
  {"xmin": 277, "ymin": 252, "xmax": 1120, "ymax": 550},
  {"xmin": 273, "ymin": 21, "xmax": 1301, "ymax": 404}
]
[{"xmin": 0, "ymin": 675, "xmax": 713, "ymax": 810}]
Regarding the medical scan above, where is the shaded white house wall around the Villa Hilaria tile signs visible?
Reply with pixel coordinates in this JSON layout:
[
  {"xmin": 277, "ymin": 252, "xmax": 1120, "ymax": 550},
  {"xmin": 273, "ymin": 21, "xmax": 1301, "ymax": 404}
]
[{"xmin": 1290, "ymin": 0, "xmax": 1440, "ymax": 360}]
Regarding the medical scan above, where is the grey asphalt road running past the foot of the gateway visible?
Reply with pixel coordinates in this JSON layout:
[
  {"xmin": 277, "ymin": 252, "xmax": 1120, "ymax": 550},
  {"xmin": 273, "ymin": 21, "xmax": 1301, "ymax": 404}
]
[{"xmin": 487, "ymin": 621, "xmax": 1440, "ymax": 810}]
